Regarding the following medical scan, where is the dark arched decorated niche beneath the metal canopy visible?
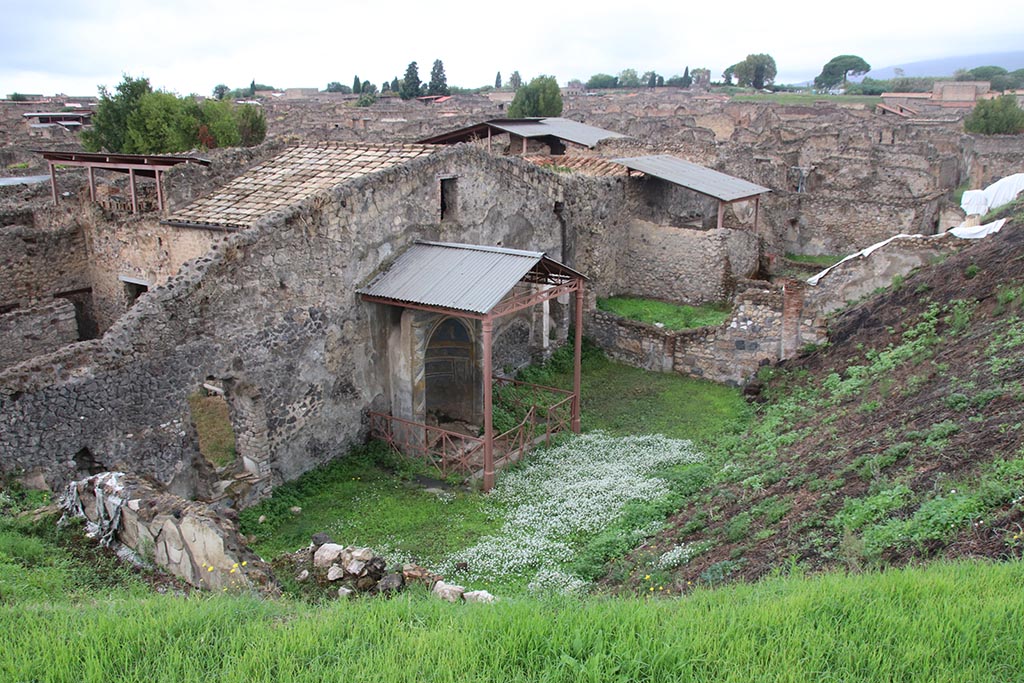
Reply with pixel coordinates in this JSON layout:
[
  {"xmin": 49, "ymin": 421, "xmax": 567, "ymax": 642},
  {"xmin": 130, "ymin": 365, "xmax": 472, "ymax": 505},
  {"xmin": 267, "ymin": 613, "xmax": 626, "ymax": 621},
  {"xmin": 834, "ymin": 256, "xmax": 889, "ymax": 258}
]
[{"xmin": 424, "ymin": 317, "xmax": 480, "ymax": 436}]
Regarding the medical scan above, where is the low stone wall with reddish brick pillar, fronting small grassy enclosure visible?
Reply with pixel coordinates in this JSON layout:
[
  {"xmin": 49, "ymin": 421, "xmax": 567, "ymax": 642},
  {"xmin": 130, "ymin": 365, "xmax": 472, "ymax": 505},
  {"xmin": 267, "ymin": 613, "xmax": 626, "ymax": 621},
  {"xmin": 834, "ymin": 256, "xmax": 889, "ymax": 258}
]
[{"xmin": 588, "ymin": 281, "xmax": 825, "ymax": 386}]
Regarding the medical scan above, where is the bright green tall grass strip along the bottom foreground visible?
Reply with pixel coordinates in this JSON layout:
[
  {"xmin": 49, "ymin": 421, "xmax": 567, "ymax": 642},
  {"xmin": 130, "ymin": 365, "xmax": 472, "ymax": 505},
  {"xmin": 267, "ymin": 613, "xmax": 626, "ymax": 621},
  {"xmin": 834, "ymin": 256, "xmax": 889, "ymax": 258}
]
[{"xmin": 0, "ymin": 562, "xmax": 1024, "ymax": 683}]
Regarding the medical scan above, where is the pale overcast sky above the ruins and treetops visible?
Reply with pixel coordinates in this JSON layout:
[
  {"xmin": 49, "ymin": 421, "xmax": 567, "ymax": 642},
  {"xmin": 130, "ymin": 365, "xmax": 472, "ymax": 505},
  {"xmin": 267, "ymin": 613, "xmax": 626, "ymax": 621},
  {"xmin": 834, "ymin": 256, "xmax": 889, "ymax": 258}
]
[{"xmin": 0, "ymin": 0, "xmax": 1024, "ymax": 95}]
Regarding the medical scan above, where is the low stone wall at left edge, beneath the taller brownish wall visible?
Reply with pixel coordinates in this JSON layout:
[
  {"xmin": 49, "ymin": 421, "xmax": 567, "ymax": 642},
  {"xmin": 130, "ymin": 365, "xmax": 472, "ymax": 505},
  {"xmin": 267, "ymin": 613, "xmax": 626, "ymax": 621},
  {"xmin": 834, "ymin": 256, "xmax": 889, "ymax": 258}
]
[{"xmin": 0, "ymin": 299, "xmax": 78, "ymax": 369}]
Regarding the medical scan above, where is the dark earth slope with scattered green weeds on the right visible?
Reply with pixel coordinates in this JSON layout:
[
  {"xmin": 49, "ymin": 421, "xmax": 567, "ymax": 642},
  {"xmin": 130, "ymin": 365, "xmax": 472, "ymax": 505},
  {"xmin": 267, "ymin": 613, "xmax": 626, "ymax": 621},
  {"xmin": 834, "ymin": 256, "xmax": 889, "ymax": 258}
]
[{"xmin": 606, "ymin": 205, "xmax": 1024, "ymax": 591}]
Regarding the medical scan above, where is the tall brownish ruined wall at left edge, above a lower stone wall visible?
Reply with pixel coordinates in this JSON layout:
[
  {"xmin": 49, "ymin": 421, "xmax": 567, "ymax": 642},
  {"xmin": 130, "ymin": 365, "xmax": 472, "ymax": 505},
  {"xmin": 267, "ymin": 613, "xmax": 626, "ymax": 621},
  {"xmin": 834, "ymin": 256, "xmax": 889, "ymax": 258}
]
[{"xmin": 0, "ymin": 209, "xmax": 90, "ymax": 306}]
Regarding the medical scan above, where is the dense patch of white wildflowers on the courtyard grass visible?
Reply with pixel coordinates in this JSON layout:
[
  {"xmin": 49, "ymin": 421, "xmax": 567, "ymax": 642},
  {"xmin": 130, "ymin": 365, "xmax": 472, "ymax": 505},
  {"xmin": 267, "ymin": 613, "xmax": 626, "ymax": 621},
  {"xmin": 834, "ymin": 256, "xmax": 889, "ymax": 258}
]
[{"xmin": 437, "ymin": 432, "xmax": 703, "ymax": 592}]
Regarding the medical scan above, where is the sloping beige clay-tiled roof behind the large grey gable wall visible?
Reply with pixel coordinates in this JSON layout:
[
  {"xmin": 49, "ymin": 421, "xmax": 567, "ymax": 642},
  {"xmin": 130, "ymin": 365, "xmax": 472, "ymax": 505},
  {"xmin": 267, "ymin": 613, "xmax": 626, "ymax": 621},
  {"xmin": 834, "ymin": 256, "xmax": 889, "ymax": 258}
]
[{"xmin": 167, "ymin": 143, "xmax": 437, "ymax": 228}]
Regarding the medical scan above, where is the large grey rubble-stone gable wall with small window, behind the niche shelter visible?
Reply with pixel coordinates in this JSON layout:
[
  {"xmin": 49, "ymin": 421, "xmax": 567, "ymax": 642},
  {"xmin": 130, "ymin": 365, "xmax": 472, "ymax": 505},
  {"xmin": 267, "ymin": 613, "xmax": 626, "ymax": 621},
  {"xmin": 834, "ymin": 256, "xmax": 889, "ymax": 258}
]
[{"xmin": 0, "ymin": 147, "xmax": 577, "ymax": 495}]
